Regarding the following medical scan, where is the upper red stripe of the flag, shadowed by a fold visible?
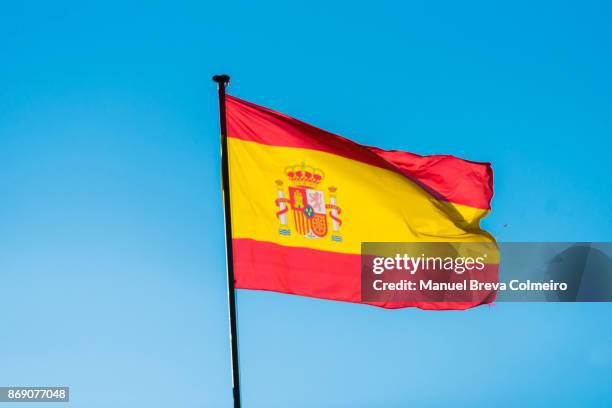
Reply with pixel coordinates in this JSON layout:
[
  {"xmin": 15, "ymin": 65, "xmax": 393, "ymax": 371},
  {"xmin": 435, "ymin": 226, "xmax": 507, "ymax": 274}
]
[{"xmin": 226, "ymin": 95, "xmax": 493, "ymax": 209}]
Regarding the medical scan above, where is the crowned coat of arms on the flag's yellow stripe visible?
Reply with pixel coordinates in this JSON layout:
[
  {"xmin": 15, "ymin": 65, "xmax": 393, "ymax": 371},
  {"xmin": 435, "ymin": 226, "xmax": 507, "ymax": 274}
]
[{"xmin": 275, "ymin": 163, "xmax": 342, "ymax": 242}]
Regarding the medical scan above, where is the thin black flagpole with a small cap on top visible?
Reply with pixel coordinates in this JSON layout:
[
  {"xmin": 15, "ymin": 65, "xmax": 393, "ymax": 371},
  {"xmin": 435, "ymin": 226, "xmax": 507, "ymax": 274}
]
[{"xmin": 213, "ymin": 75, "xmax": 240, "ymax": 408}]
